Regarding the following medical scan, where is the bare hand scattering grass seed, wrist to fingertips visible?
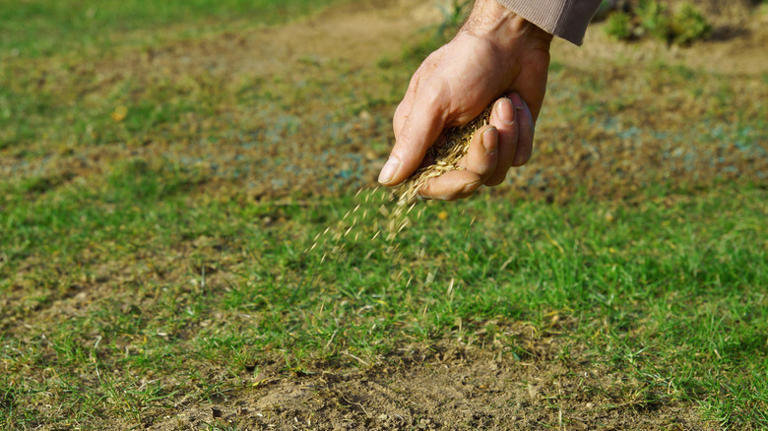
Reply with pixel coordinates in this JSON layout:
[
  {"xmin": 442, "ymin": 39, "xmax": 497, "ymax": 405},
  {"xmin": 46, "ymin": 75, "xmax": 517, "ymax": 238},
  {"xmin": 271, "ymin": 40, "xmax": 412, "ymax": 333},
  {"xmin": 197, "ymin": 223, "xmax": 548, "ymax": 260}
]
[{"xmin": 379, "ymin": 0, "xmax": 552, "ymax": 199}]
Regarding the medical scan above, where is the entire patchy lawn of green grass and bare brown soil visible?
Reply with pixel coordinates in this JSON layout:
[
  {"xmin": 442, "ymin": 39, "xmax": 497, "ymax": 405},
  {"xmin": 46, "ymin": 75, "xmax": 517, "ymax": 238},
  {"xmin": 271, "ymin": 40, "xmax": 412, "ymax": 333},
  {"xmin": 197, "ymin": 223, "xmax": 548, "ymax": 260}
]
[{"xmin": 0, "ymin": 0, "xmax": 768, "ymax": 430}]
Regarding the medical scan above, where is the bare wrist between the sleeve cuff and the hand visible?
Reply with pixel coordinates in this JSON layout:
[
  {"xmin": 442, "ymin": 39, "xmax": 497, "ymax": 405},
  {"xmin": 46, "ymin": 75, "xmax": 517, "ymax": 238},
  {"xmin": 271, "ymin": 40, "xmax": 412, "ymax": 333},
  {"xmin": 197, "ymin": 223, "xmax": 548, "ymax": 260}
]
[{"xmin": 461, "ymin": 0, "xmax": 552, "ymax": 51}]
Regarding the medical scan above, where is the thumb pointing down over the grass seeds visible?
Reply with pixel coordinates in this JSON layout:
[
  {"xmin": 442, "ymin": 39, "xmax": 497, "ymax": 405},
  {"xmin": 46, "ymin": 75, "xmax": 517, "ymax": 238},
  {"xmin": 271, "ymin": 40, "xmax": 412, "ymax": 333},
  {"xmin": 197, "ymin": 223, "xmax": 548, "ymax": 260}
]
[{"xmin": 379, "ymin": 100, "xmax": 445, "ymax": 186}]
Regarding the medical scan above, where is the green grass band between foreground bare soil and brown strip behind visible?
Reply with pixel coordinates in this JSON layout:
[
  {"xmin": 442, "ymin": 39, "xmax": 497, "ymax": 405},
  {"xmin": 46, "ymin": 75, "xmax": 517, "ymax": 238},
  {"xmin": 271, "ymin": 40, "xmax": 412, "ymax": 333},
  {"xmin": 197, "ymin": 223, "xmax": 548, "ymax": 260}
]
[{"xmin": 0, "ymin": 161, "xmax": 768, "ymax": 426}]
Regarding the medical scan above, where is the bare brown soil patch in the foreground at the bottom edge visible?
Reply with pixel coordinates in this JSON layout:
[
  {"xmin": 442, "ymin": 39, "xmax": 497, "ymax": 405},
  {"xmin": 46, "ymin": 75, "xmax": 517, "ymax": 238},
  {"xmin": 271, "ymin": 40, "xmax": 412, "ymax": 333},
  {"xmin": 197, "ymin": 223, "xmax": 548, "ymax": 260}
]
[{"xmin": 149, "ymin": 325, "xmax": 714, "ymax": 431}]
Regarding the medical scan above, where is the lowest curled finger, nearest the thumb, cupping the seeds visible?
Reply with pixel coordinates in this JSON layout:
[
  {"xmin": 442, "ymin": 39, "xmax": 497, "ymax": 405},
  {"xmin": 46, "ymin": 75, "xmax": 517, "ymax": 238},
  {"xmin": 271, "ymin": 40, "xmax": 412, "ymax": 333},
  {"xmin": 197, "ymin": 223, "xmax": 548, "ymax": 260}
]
[{"xmin": 419, "ymin": 125, "xmax": 499, "ymax": 200}]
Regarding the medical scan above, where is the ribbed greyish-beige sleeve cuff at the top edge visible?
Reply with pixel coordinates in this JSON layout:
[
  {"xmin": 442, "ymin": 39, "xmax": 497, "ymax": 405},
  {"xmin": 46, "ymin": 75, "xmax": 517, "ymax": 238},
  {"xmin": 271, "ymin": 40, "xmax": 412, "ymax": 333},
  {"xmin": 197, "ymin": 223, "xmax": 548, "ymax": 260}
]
[{"xmin": 498, "ymin": 0, "xmax": 600, "ymax": 45}]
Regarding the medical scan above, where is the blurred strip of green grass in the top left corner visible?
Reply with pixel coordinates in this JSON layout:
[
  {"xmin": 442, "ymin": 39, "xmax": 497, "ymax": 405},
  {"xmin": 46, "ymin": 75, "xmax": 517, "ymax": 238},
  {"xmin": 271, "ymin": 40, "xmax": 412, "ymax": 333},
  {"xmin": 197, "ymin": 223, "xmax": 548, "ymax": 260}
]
[{"xmin": 0, "ymin": 0, "xmax": 344, "ymax": 58}]
